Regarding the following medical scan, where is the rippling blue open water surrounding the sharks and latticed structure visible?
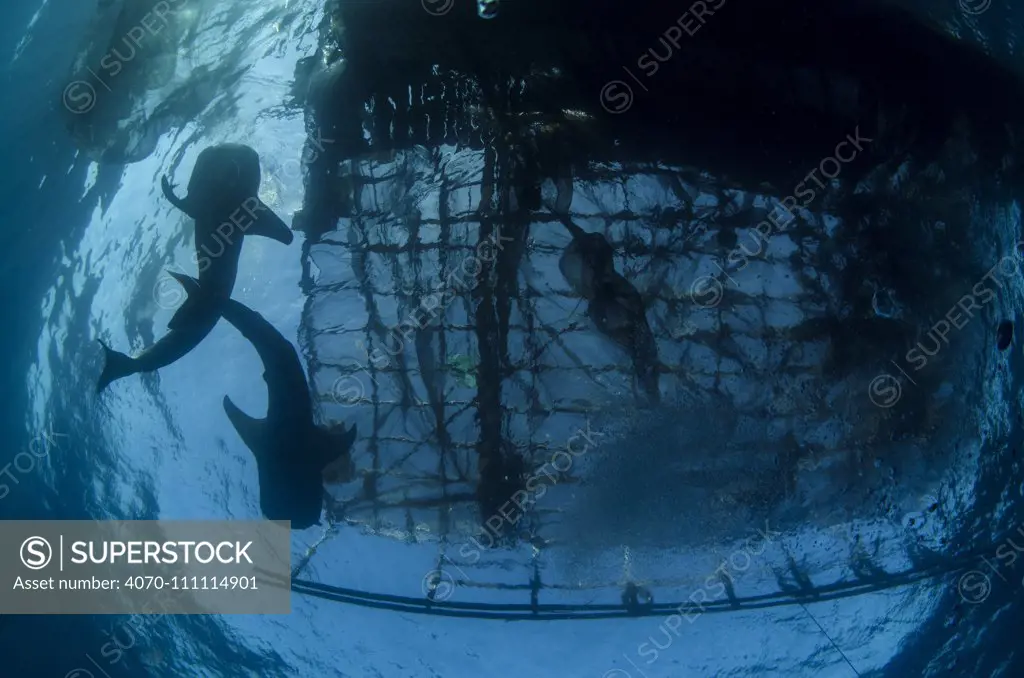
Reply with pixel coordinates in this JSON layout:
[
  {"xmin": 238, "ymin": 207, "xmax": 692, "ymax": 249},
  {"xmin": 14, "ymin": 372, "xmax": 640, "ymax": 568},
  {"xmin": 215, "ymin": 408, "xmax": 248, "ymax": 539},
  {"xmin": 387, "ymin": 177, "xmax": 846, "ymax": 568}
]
[{"xmin": 6, "ymin": 0, "xmax": 1024, "ymax": 678}]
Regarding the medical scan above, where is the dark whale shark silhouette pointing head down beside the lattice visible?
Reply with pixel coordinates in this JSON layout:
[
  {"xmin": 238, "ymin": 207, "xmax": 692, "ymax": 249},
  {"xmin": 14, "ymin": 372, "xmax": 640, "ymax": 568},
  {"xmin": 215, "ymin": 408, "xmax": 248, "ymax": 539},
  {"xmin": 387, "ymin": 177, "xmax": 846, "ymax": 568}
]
[{"xmin": 222, "ymin": 300, "xmax": 355, "ymax": 529}]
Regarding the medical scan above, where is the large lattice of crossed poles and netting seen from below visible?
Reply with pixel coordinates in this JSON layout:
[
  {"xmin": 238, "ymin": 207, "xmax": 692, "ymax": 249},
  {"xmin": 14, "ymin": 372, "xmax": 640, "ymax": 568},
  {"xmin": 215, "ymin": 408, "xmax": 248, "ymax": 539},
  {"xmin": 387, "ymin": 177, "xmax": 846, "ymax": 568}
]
[{"xmin": 282, "ymin": 3, "xmax": 1021, "ymax": 626}]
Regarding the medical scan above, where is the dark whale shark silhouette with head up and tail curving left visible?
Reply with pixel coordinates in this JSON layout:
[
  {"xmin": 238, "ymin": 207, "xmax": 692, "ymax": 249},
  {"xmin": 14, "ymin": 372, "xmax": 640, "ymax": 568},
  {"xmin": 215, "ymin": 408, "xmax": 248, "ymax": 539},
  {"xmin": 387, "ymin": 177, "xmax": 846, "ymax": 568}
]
[{"xmin": 97, "ymin": 143, "xmax": 294, "ymax": 392}]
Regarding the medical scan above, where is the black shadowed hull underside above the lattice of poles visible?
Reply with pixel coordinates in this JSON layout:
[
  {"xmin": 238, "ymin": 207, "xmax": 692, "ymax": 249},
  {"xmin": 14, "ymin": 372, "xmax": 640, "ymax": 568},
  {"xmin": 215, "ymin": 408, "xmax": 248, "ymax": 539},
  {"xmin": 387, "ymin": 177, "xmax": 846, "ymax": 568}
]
[{"xmin": 296, "ymin": 0, "xmax": 1024, "ymax": 219}]
